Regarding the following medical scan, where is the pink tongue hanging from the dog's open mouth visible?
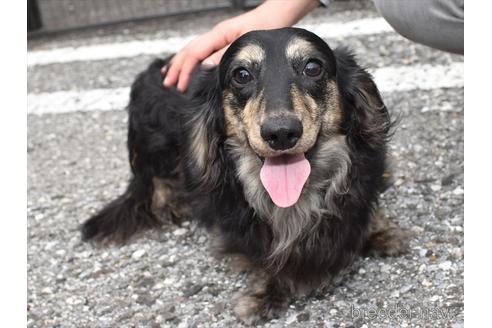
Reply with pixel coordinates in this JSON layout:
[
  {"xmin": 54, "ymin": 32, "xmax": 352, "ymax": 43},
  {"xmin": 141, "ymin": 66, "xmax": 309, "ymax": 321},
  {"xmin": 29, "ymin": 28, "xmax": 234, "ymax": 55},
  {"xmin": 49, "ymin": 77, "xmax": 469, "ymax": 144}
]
[{"xmin": 260, "ymin": 154, "xmax": 311, "ymax": 207}]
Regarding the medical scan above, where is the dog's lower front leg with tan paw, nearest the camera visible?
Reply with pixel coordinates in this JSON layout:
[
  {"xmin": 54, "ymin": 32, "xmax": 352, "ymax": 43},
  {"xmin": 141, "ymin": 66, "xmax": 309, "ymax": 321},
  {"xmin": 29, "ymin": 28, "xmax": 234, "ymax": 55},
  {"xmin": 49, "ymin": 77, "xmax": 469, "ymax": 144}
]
[{"xmin": 234, "ymin": 271, "xmax": 294, "ymax": 325}]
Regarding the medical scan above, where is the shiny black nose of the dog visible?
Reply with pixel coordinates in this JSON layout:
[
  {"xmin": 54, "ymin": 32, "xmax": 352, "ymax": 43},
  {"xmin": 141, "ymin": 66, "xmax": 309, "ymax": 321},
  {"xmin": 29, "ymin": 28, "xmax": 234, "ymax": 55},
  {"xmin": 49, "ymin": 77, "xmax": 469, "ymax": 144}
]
[{"xmin": 260, "ymin": 117, "xmax": 302, "ymax": 150}]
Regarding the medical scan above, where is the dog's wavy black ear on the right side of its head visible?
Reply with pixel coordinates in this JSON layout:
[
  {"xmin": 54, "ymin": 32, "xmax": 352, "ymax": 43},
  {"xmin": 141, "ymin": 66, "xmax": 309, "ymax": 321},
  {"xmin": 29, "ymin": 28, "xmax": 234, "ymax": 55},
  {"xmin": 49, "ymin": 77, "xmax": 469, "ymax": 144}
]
[{"xmin": 335, "ymin": 48, "xmax": 393, "ymax": 148}]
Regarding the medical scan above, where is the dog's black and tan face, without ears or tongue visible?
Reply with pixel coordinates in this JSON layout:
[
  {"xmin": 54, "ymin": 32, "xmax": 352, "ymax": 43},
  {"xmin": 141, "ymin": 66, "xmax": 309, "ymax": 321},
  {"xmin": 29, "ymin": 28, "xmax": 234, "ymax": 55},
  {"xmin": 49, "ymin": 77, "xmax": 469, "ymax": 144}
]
[{"xmin": 220, "ymin": 28, "xmax": 340, "ymax": 158}]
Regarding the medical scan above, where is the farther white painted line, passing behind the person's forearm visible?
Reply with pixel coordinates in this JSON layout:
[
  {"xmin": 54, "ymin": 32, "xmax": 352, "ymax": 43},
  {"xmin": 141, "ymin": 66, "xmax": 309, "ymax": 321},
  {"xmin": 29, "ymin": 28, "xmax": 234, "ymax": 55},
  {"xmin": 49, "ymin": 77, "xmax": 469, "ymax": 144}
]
[{"xmin": 27, "ymin": 18, "xmax": 392, "ymax": 66}]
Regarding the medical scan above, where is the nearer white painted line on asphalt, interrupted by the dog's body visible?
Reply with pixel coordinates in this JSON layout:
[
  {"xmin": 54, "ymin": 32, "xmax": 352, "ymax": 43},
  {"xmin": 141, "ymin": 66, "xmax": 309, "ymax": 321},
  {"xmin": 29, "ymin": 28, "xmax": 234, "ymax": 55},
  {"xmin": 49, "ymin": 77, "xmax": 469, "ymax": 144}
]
[{"xmin": 27, "ymin": 62, "xmax": 464, "ymax": 114}]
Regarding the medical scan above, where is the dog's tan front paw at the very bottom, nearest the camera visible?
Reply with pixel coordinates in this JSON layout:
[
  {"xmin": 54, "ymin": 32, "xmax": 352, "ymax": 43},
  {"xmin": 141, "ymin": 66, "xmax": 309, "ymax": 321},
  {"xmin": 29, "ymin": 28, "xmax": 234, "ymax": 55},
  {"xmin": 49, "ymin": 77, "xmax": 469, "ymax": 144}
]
[{"xmin": 234, "ymin": 293, "xmax": 288, "ymax": 326}]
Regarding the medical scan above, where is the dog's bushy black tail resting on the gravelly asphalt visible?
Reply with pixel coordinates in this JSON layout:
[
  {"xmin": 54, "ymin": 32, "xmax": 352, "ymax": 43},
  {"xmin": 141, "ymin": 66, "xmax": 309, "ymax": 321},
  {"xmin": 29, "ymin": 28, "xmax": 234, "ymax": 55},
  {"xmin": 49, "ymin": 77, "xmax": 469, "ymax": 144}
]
[{"xmin": 81, "ymin": 177, "xmax": 161, "ymax": 243}]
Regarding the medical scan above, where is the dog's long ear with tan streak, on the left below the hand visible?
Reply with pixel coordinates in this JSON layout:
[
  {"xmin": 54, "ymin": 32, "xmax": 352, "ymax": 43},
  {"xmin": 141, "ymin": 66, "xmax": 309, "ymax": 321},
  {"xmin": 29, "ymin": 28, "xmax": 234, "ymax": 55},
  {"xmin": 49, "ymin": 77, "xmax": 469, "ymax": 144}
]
[{"xmin": 184, "ymin": 69, "xmax": 225, "ymax": 192}]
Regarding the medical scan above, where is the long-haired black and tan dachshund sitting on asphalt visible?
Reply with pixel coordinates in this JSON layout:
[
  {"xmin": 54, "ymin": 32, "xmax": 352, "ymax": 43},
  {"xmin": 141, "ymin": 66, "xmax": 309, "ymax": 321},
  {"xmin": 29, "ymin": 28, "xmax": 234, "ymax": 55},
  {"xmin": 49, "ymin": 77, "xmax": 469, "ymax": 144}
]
[{"xmin": 82, "ymin": 28, "xmax": 407, "ymax": 324}]
